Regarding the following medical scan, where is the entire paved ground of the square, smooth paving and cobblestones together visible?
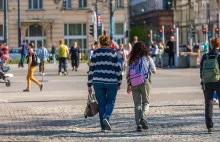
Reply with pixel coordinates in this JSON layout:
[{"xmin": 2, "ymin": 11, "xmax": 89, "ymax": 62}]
[{"xmin": 0, "ymin": 64, "xmax": 220, "ymax": 142}]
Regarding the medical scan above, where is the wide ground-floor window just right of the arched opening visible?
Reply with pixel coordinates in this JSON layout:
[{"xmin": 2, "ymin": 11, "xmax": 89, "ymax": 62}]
[{"xmin": 64, "ymin": 24, "xmax": 87, "ymax": 51}]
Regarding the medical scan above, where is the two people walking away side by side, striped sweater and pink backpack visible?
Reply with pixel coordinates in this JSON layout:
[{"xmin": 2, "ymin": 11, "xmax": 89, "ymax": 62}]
[{"xmin": 88, "ymin": 36, "xmax": 156, "ymax": 132}]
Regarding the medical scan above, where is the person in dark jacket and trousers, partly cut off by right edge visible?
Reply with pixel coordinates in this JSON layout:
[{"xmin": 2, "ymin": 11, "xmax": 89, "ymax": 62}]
[{"xmin": 200, "ymin": 38, "xmax": 220, "ymax": 134}]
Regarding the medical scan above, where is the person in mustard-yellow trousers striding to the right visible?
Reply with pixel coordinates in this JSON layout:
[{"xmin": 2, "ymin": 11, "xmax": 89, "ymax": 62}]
[{"xmin": 23, "ymin": 43, "xmax": 43, "ymax": 92}]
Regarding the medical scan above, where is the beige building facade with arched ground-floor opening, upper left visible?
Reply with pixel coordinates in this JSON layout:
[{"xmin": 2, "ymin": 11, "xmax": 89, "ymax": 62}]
[{"xmin": 0, "ymin": 0, "xmax": 129, "ymax": 50}]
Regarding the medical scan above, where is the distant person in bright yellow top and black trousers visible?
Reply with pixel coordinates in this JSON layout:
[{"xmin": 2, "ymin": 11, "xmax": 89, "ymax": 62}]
[{"xmin": 58, "ymin": 39, "xmax": 69, "ymax": 75}]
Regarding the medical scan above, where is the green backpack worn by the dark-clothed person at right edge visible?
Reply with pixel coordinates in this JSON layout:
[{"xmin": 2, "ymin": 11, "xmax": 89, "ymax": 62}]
[{"xmin": 202, "ymin": 54, "xmax": 220, "ymax": 83}]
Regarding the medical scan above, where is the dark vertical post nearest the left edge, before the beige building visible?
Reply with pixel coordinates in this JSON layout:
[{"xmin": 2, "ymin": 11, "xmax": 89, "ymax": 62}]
[{"xmin": 4, "ymin": 0, "xmax": 8, "ymax": 45}]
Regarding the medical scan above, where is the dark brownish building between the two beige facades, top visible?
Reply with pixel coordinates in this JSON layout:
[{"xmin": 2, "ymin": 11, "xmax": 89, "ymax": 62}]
[{"xmin": 130, "ymin": 0, "xmax": 173, "ymax": 41}]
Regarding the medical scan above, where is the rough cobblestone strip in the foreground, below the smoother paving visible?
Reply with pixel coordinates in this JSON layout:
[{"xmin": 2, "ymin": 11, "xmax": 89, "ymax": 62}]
[{"xmin": 0, "ymin": 100, "xmax": 220, "ymax": 142}]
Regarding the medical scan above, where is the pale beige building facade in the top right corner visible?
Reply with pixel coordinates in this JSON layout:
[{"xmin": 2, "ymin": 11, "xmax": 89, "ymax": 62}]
[{"xmin": 173, "ymin": 0, "xmax": 220, "ymax": 44}]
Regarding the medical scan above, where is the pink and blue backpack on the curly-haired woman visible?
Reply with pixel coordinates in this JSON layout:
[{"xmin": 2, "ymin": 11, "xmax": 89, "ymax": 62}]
[{"xmin": 129, "ymin": 58, "xmax": 149, "ymax": 86}]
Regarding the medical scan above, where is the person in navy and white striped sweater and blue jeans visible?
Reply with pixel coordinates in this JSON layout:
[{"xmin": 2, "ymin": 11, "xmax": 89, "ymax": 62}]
[{"xmin": 88, "ymin": 36, "xmax": 122, "ymax": 131}]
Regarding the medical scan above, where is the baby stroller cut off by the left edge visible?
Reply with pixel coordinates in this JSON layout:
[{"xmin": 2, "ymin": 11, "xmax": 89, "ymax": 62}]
[{"xmin": 0, "ymin": 55, "xmax": 14, "ymax": 87}]
